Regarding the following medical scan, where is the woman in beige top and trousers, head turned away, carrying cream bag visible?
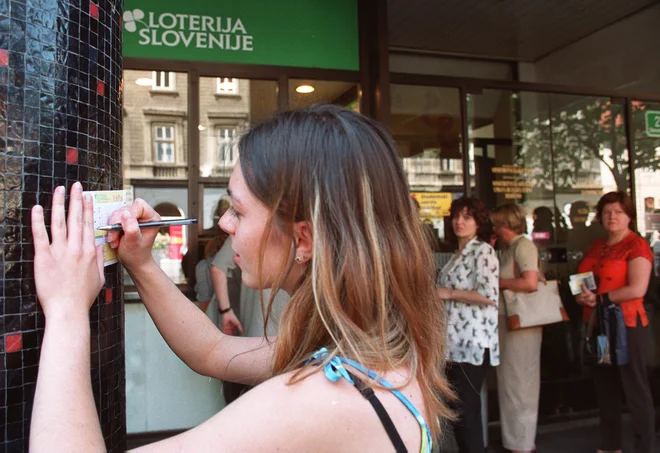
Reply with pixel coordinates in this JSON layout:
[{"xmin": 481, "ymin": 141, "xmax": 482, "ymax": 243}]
[{"xmin": 490, "ymin": 204, "xmax": 543, "ymax": 453}]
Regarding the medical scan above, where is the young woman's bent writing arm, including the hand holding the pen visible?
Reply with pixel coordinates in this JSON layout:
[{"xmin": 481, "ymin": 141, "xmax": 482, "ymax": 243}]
[{"xmin": 108, "ymin": 199, "xmax": 273, "ymax": 385}]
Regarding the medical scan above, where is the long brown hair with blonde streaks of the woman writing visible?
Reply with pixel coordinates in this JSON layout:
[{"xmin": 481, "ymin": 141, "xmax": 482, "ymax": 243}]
[{"xmin": 239, "ymin": 105, "xmax": 453, "ymax": 435}]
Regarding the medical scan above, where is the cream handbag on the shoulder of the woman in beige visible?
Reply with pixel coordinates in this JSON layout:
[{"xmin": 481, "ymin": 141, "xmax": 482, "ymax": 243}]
[{"xmin": 502, "ymin": 254, "xmax": 568, "ymax": 330}]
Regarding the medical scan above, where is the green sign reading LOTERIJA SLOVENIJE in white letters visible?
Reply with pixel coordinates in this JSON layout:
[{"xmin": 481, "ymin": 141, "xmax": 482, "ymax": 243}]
[{"xmin": 123, "ymin": 0, "xmax": 359, "ymax": 70}]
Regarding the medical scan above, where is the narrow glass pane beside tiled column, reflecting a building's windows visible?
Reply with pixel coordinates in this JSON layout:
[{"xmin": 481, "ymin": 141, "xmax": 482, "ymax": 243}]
[{"xmin": 123, "ymin": 70, "xmax": 189, "ymax": 285}]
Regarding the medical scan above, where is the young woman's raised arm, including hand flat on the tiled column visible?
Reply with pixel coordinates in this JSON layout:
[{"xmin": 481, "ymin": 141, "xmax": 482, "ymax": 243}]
[{"xmin": 30, "ymin": 183, "xmax": 105, "ymax": 453}]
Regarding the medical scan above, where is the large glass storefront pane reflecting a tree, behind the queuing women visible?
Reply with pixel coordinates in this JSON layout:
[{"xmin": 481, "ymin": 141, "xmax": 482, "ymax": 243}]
[{"xmin": 468, "ymin": 90, "xmax": 629, "ymax": 413}]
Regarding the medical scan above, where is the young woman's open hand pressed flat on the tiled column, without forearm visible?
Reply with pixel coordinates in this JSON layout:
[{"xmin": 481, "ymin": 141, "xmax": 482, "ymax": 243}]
[{"xmin": 32, "ymin": 182, "xmax": 105, "ymax": 319}]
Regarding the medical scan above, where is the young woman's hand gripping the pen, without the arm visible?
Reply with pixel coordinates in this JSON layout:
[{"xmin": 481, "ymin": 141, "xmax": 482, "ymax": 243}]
[{"xmin": 107, "ymin": 198, "xmax": 160, "ymax": 270}]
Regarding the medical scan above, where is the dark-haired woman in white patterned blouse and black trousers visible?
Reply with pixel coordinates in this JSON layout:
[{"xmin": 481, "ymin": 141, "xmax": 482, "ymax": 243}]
[{"xmin": 437, "ymin": 197, "xmax": 500, "ymax": 453}]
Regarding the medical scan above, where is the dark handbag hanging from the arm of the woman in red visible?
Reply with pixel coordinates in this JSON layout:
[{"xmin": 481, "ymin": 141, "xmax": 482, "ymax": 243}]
[{"xmin": 584, "ymin": 298, "xmax": 628, "ymax": 366}]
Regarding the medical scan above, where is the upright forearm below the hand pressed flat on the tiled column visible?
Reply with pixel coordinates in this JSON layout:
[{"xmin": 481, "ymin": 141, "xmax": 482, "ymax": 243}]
[{"xmin": 30, "ymin": 312, "xmax": 105, "ymax": 453}]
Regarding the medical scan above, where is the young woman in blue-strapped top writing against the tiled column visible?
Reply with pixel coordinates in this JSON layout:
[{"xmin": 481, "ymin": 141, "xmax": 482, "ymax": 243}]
[{"xmin": 30, "ymin": 106, "xmax": 451, "ymax": 452}]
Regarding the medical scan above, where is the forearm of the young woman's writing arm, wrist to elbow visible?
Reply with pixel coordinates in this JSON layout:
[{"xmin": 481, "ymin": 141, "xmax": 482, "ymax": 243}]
[{"xmin": 129, "ymin": 263, "xmax": 224, "ymax": 376}]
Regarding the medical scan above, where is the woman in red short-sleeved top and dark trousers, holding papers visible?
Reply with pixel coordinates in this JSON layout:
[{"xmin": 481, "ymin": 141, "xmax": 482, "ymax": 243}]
[{"xmin": 577, "ymin": 192, "xmax": 655, "ymax": 453}]
